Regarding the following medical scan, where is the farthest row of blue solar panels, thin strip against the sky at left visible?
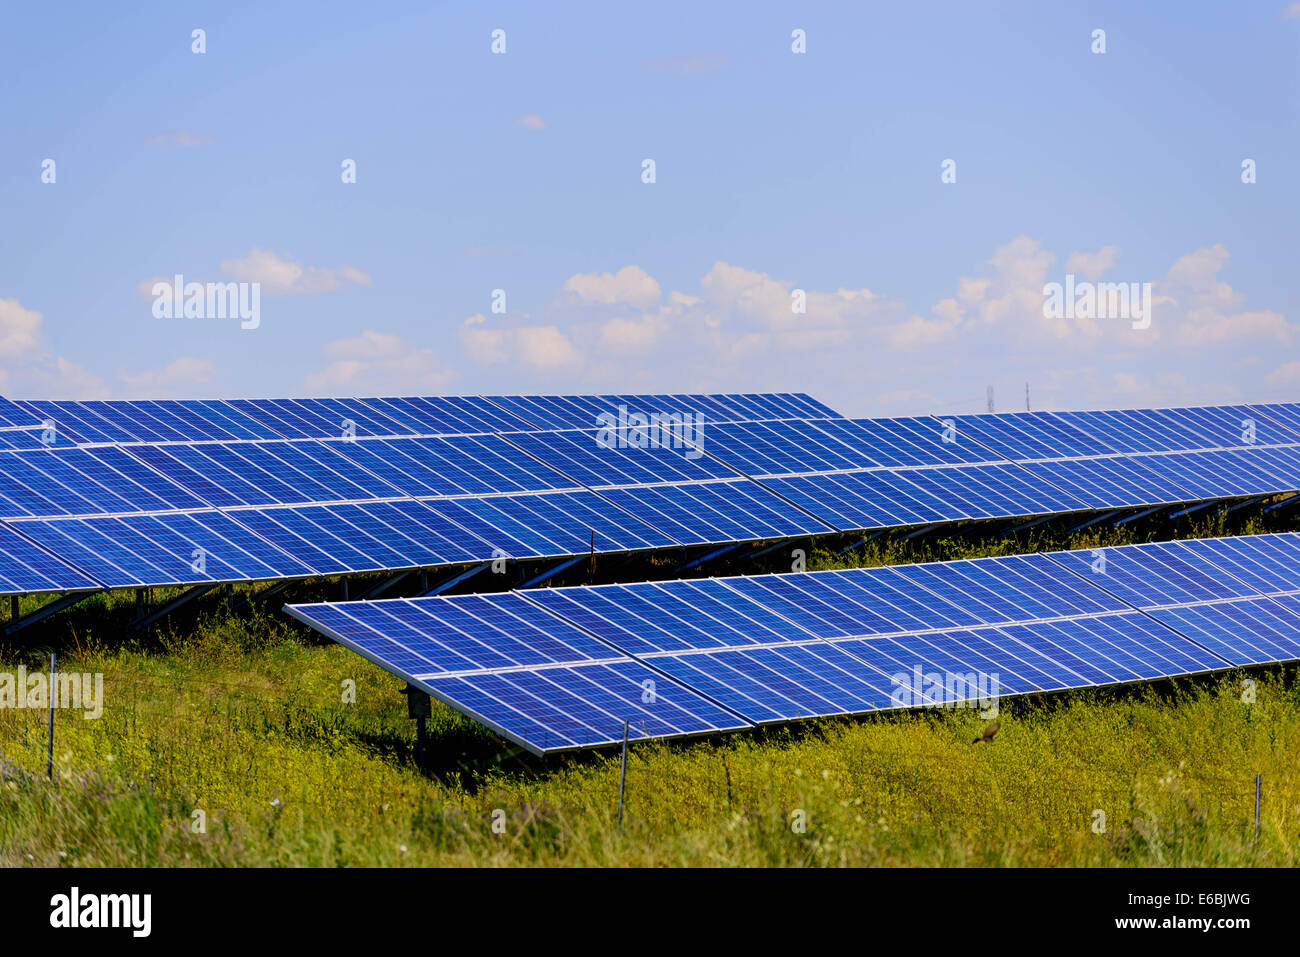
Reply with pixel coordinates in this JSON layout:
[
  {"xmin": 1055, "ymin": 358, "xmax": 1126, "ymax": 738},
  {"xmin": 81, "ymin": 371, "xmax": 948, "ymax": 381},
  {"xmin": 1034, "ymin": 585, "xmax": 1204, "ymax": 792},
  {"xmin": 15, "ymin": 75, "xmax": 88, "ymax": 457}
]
[{"xmin": 0, "ymin": 393, "xmax": 839, "ymax": 450}]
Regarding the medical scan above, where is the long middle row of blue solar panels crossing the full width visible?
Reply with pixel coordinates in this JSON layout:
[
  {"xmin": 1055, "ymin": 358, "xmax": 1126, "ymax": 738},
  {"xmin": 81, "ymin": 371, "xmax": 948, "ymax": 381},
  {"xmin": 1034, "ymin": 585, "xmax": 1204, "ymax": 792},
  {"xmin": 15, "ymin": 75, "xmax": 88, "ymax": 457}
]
[{"xmin": 0, "ymin": 397, "xmax": 1300, "ymax": 593}]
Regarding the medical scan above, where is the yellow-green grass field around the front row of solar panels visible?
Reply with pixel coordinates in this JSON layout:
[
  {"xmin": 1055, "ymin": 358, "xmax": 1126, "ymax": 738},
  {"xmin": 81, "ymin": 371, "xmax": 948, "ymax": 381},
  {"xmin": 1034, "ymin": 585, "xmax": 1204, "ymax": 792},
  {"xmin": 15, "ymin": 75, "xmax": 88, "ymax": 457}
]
[{"xmin": 0, "ymin": 512, "xmax": 1300, "ymax": 866}]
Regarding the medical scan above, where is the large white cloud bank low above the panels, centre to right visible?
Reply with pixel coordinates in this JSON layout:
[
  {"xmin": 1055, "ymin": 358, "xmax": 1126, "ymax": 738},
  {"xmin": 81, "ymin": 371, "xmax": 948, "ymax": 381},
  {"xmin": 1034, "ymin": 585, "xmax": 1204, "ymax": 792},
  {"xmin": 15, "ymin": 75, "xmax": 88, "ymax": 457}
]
[{"xmin": 460, "ymin": 235, "xmax": 1294, "ymax": 415}]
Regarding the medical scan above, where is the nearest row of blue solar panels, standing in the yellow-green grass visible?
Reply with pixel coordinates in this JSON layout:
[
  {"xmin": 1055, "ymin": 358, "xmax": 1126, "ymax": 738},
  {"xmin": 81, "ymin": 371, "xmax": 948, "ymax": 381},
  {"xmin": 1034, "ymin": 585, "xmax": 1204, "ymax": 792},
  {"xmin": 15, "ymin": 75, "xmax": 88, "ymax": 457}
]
[{"xmin": 286, "ymin": 533, "xmax": 1300, "ymax": 754}]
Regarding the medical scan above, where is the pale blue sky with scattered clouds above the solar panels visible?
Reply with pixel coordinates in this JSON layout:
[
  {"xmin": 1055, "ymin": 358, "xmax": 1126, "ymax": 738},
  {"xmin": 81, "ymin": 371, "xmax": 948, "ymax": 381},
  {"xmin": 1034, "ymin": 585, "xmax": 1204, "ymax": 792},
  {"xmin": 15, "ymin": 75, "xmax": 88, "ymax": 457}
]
[{"xmin": 0, "ymin": 0, "xmax": 1300, "ymax": 415}]
